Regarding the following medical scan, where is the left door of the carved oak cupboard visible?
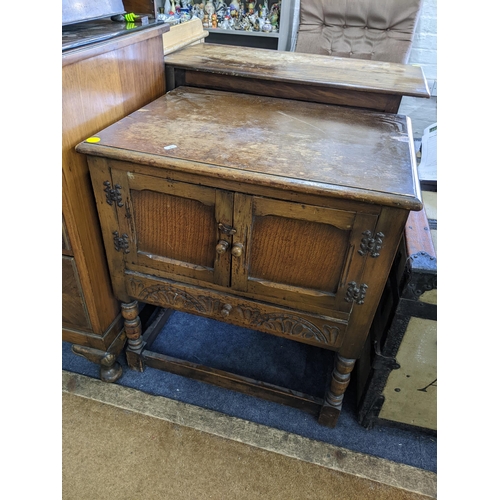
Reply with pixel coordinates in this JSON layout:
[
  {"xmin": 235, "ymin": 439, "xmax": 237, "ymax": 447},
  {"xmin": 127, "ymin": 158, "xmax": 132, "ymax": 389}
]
[{"xmin": 112, "ymin": 170, "xmax": 233, "ymax": 286}]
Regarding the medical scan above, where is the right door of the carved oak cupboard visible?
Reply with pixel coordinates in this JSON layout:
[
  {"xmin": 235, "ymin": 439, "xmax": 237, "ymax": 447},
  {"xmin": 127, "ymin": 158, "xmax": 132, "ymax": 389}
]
[{"xmin": 231, "ymin": 193, "xmax": 377, "ymax": 314}]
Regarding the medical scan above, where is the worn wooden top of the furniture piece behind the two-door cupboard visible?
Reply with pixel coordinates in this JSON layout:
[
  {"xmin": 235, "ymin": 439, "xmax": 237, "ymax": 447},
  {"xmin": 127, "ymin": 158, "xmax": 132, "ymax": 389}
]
[{"xmin": 165, "ymin": 43, "xmax": 430, "ymax": 98}]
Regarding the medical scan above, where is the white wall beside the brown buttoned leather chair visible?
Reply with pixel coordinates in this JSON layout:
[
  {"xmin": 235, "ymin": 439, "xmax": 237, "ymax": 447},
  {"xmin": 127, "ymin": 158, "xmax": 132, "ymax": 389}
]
[{"xmin": 408, "ymin": 0, "xmax": 437, "ymax": 96}]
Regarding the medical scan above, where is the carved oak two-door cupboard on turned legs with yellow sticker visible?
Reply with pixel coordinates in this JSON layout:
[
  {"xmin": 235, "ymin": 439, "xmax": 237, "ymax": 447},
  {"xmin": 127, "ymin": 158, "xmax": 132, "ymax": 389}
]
[{"xmin": 76, "ymin": 86, "xmax": 422, "ymax": 427}]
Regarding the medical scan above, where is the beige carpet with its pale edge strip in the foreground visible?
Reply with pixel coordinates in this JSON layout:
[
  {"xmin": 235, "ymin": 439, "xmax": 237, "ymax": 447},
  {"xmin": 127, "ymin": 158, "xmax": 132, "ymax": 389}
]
[{"xmin": 62, "ymin": 372, "xmax": 436, "ymax": 500}]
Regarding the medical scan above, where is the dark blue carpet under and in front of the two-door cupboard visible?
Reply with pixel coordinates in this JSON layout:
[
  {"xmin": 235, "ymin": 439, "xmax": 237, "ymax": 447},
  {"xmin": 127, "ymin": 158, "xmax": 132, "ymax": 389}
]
[{"xmin": 62, "ymin": 312, "xmax": 437, "ymax": 472}]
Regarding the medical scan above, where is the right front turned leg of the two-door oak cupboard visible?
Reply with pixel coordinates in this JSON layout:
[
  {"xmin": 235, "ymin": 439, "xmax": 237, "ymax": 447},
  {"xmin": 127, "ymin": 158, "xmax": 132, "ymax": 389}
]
[{"xmin": 318, "ymin": 353, "xmax": 356, "ymax": 427}]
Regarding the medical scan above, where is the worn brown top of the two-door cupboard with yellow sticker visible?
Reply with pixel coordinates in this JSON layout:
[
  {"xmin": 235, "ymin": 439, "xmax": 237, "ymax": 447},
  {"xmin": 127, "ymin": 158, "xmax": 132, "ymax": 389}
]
[{"xmin": 77, "ymin": 87, "xmax": 421, "ymax": 210}]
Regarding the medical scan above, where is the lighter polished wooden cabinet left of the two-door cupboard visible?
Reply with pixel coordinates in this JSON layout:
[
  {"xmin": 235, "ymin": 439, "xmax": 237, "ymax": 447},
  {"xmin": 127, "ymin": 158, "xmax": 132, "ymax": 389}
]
[{"xmin": 62, "ymin": 21, "xmax": 169, "ymax": 381}]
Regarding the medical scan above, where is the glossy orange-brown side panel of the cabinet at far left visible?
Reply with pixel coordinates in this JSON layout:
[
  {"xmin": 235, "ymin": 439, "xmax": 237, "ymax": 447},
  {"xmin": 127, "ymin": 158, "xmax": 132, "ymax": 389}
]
[{"xmin": 62, "ymin": 33, "xmax": 166, "ymax": 335}]
